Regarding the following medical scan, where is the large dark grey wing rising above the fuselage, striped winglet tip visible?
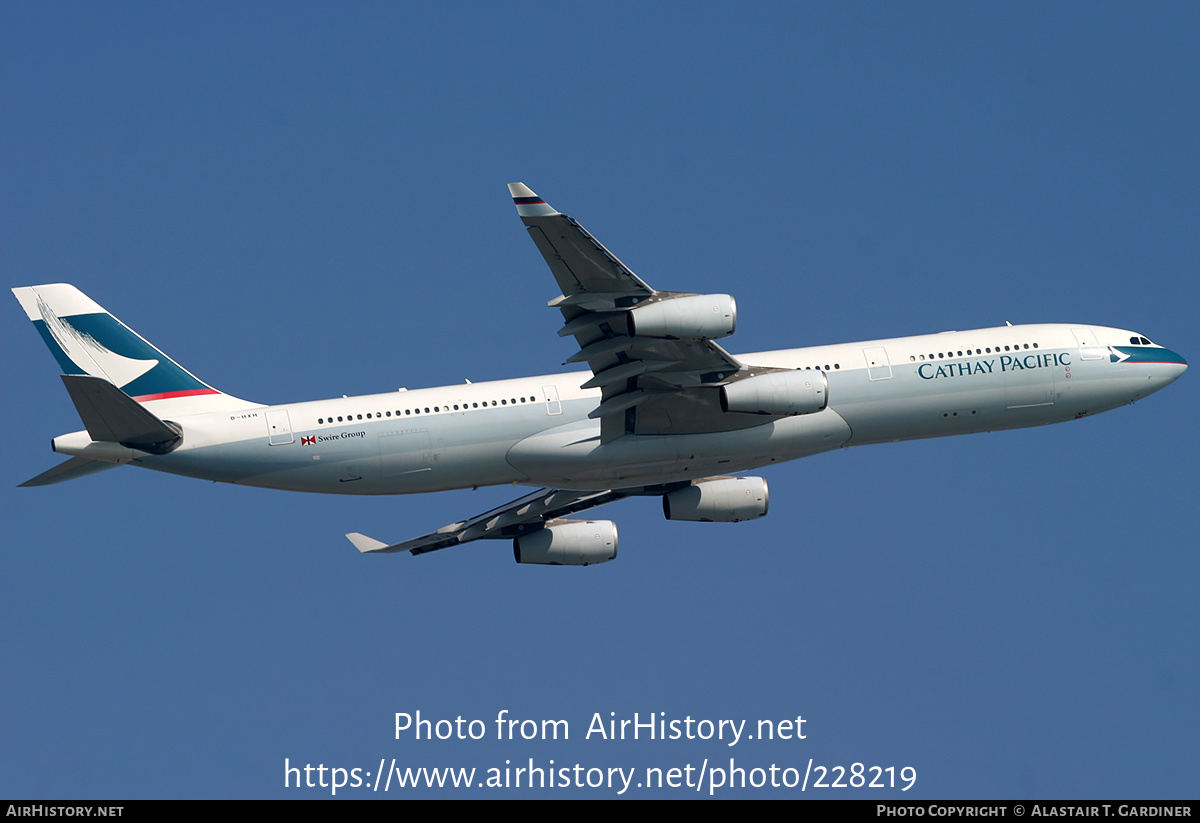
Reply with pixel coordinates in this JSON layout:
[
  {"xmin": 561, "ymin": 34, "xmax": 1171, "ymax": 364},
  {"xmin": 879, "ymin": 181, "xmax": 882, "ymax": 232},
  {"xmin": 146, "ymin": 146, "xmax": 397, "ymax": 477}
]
[{"xmin": 509, "ymin": 182, "xmax": 762, "ymax": 443}]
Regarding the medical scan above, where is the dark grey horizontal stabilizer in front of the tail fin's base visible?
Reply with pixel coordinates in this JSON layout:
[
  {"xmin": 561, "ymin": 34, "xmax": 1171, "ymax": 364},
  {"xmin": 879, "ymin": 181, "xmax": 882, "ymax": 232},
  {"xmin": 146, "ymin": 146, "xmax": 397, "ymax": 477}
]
[{"xmin": 61, "ymin": 374, "xmax": 182, "ymax": 455}]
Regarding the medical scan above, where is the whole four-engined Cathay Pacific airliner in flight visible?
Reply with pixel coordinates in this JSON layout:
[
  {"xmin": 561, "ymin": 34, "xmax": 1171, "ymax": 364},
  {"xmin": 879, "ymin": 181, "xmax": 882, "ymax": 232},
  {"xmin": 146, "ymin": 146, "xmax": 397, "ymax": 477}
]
[{"xmin": 13, "ymin": 182, "xmax": 1187, "ymax": 565}]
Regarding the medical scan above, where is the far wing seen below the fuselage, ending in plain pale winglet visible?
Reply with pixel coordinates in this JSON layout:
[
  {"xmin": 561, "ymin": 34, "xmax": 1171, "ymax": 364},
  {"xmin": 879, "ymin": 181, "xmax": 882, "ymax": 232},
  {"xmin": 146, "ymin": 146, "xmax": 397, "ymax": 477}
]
[{"xmin": 346, "ymin": 483, "xmax": 648, "ymax": 555}]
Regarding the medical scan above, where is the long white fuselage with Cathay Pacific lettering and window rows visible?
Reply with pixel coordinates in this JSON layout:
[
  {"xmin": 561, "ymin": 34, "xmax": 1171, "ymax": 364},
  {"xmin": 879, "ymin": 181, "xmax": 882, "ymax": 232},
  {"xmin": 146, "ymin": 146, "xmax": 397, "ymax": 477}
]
[{"xmin": 54, "ymin": 324, "xmax": 1187, "ymax": 494}]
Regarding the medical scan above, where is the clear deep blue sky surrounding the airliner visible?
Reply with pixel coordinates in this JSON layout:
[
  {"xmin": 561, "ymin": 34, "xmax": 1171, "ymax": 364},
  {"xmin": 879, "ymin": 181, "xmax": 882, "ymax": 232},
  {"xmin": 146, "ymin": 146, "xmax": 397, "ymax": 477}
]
[{"xmin": 0, "ymin": 2, "xmax": 1200, "ymax": 798}]
